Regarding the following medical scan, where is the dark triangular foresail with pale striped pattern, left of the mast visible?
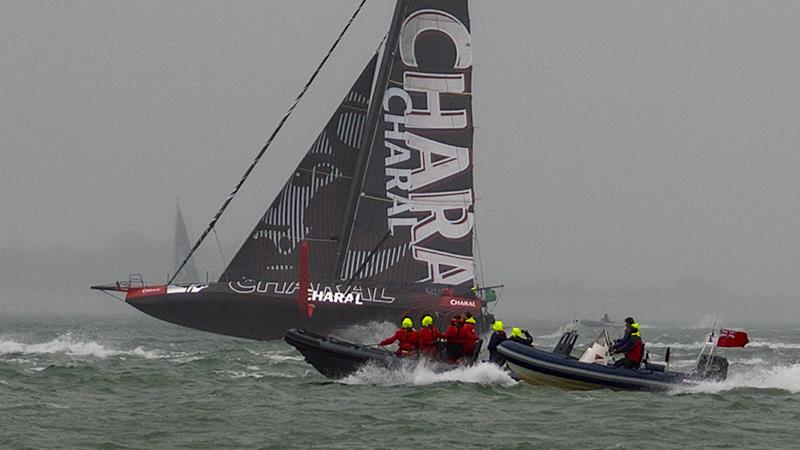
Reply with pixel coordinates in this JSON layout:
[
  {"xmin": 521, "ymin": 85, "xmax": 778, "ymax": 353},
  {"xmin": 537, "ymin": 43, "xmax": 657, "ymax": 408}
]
[{"xmin": 220, "ymin": 55, "xmax": 377, "ymax": 281}]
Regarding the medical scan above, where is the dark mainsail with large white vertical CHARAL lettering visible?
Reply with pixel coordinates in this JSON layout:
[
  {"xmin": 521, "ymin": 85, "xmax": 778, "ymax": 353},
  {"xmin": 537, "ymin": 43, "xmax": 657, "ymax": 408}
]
[{"xmin": 339, "ymin": 0, "xmax": 475, "ymax": 287}]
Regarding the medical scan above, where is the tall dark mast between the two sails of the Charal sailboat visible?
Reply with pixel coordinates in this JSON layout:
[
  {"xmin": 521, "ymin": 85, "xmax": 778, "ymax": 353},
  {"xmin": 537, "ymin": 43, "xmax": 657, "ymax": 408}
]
[{"xmin": 335, "ymin": 0, "xmax": 406, "ymax": 278}]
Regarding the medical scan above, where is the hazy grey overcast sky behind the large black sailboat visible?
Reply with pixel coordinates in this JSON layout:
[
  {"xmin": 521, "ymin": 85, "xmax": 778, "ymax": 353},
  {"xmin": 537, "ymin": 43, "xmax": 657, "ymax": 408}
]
[{"xmin": 0, "ymin": 0, "xmax": 800, "ymax": 318}]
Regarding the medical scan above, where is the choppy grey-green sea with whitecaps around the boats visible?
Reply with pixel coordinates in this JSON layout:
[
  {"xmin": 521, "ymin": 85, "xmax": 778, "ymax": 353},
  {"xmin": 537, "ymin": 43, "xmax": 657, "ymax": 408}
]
[{"xmin": 0, "ymin": 316, "xmax": 800, "ymax": 450}]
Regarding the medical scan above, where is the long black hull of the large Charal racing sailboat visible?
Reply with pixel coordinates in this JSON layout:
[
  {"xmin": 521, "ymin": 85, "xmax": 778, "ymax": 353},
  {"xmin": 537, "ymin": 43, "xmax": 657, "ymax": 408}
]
[{"xmin": 126, "ymin": 284, "xmax": 486, "ymax": 340}]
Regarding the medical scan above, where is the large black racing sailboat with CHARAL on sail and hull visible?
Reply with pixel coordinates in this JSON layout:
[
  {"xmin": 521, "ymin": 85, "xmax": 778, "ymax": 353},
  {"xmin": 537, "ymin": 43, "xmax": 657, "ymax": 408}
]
[{"xmin": 93, "ymin": 0, "xmax": 492, "ymax": 339}]
